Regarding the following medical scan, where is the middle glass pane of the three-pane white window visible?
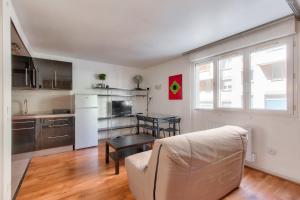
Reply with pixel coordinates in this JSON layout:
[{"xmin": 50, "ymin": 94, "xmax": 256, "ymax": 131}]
[{"xmin": 218, "ymin": 55, "xmax": 243, "ymax": 108}]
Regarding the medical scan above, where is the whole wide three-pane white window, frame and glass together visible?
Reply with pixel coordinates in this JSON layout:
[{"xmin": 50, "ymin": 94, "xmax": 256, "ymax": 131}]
[{"xmin": 195, "ymin": 37, "xmax": 294, "ymax": 114}]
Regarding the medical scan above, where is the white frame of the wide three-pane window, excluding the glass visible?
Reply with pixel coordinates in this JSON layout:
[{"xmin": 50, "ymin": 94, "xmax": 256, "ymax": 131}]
[{"xmin": 192, "ymin": 36, "xmax": 297, "ymax": 115}]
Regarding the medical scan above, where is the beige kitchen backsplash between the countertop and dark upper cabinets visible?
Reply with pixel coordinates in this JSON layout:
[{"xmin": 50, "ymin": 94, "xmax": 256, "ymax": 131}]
[{"xmin": 12, "ymin": 90, "xmax": 73, "ymax": 115}]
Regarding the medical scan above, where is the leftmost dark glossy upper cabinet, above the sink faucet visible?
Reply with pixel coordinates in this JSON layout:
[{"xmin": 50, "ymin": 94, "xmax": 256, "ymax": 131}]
[{"xmin": 12, "ymin": 55, "xmax": 37, "ymax": 89}]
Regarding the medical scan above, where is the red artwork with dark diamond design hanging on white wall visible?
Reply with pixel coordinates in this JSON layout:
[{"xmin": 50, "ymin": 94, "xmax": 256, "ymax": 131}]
[{"xmin": 169, "ymin": 74, "xmax": 182, "ymax": 100}]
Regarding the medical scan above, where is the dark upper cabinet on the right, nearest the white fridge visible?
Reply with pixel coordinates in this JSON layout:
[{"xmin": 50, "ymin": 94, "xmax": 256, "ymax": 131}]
[{"xmin": 33, "ymin": 58, "xmax": 72, "ymax": 90}]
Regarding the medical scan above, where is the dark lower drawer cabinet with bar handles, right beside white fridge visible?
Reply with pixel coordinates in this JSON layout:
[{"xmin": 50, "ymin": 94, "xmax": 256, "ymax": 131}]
[{"xmin": 38, "ymin": 117, "xmax": 74, "ymax": 149}]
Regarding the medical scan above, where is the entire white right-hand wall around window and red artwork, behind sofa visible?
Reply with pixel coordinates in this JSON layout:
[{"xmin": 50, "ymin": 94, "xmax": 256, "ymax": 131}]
[{"xmin": 145, "ymin": 23, "xmax": 300, "ymax": 183}]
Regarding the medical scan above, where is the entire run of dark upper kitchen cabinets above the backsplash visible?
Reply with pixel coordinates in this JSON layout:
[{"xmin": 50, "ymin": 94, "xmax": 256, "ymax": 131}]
[{"xmin": 11, "ymin": 22, "xmax": 72, "ymax": 90}]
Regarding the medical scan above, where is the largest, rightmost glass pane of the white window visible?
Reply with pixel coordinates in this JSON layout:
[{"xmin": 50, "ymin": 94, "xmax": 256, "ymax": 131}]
[{"xmin": 250, "ymin": 45, "xmax": 287, "ymax": 110}]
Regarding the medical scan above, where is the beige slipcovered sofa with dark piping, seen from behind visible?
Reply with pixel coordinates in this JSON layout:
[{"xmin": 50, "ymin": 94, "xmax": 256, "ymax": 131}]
[{"xmin": 125, "ymin": 126, "xmax": 247, "ymax": 200}]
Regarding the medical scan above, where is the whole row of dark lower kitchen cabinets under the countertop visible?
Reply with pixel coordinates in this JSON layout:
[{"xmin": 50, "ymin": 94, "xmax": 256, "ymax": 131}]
[{"xmin": 12, "ymin": 117, "xmax": 75, "ymax": 154}]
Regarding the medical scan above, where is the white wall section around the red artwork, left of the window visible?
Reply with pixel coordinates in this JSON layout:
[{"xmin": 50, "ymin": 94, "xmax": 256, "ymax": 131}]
[{"xmin": 144, "ymin": 56, "xmax": 191, "ymax": 132}]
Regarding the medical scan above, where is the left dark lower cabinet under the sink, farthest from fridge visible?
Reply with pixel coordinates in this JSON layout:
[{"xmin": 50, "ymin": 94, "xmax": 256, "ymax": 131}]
[{"xmin": 12, "ymin": 119, "xmax": 39, "ymax": 154}]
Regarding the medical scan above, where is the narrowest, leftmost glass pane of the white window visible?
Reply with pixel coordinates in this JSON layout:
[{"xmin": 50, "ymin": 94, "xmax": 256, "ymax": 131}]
[{"xmin": 196, "ymin": 62, "xmax": 214, "ymax": 109}]
